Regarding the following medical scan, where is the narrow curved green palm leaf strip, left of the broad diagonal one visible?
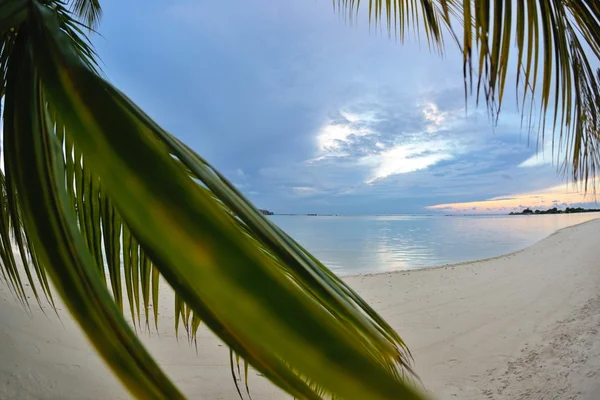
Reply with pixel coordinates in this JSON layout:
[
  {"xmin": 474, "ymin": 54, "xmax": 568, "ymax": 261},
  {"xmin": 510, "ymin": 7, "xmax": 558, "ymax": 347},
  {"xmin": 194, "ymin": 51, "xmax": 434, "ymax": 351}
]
[{"xmin": 4, "ymin": 18, "xmax": 182, "ymax": 398}]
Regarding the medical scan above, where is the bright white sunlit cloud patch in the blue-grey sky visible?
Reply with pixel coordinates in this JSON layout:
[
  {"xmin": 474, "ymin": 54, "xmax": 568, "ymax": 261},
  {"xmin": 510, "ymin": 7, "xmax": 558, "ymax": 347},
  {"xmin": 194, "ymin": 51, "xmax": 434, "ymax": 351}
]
[{"xmin": 307, "ymin": 96, "xmax": 468, "ymax": 184}]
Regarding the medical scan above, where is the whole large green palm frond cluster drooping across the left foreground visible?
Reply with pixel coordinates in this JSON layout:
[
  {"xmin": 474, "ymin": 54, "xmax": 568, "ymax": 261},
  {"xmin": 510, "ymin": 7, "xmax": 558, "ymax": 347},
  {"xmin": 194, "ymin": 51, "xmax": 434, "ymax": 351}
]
[{"xmin": 0, "ymin": 0, "xmax": 419, "ymax": 399}]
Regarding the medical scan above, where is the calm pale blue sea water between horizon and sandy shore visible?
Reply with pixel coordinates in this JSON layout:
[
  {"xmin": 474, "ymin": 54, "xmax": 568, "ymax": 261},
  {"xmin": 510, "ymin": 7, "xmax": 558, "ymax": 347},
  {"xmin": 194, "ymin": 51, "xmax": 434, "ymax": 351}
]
[{"xmin": 270, "ymin": 213, "xmax": 600, "ymax": 275}]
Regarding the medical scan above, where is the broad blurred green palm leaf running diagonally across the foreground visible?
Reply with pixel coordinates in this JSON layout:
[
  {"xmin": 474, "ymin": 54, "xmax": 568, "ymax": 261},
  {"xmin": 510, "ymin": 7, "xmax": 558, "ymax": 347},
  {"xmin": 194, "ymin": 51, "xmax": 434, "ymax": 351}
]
[{"xmin": 31, "ymin": 3, "xmax": 420, "ymax": 398}]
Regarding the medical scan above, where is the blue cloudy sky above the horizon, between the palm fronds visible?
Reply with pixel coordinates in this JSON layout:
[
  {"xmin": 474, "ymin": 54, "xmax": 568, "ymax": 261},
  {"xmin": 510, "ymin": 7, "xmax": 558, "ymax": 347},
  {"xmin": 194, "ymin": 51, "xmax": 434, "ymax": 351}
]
[{"xmin": 93, "ymin": 0, "xmax": 596, "ymax": 214}]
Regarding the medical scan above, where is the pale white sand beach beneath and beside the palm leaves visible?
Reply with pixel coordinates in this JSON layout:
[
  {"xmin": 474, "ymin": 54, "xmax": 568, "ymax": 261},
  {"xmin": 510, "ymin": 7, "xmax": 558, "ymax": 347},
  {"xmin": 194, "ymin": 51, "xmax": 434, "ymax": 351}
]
[{"xmin": 0, "ymin": 220, "xmax": 600, "ymax": 400}]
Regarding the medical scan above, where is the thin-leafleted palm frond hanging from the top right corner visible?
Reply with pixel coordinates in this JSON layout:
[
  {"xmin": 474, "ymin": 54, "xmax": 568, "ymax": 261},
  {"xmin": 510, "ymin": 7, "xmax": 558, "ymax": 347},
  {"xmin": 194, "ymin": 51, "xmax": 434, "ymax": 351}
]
[{"xmin": 334, "ymin": 0, "xmax": 600, "ymax": 190}]
